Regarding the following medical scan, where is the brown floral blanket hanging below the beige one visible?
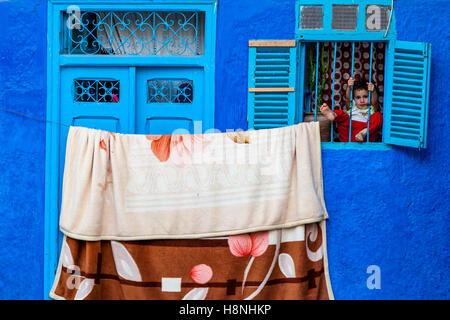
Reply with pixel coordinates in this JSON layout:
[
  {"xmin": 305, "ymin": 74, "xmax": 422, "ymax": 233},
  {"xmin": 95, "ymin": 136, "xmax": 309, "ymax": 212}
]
[{"xmin": 50, "ymin": 221, "xmax": 333, "ymax": 300}]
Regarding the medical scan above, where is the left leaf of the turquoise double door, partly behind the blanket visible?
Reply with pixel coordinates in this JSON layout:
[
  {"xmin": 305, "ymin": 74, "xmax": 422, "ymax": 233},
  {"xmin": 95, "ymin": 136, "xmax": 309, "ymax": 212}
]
[{"xmin": 58, "ymin": 67, "xmax": 134, "ymax": 249}]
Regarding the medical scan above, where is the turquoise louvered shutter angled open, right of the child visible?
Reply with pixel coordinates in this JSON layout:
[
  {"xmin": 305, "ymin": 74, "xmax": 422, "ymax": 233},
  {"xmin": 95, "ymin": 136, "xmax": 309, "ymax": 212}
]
[{"xmin": 383, "ymin": 41, "xmax": 431, "ymax": 148}]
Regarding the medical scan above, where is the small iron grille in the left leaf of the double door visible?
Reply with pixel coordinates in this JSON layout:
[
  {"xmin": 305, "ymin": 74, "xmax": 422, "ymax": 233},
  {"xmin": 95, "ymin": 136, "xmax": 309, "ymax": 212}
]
[{"xmin": 74, "ymin": 79, "xmax": 120, "ymax": 102}]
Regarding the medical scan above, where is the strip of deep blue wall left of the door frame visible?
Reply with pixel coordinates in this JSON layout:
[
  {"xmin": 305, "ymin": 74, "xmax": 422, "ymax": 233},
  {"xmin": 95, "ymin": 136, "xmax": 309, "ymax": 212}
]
[{"xmin": 0, "ymin": 0, "xmax": 47, "ymax": 299}]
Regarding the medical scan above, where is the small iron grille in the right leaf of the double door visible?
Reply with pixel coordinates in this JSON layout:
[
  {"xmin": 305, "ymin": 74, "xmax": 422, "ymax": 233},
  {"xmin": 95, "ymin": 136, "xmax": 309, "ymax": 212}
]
[{"xmin": 147, "ymin": 79, "xmax": 194, "ymax": 103}]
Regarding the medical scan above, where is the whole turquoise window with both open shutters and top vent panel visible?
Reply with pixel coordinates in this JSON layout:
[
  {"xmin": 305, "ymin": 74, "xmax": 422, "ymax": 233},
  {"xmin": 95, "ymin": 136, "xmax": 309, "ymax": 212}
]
[{"xmin": 248, "ymin": 0, "xmax": 431, "ymax": 149}]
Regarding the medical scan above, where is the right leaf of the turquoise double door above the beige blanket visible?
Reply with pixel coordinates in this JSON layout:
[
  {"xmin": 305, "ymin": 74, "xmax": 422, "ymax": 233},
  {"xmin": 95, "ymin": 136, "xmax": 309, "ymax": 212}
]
[{"xmin": 136, "ymin": 67, "xmax": 206, "ymax": 134}]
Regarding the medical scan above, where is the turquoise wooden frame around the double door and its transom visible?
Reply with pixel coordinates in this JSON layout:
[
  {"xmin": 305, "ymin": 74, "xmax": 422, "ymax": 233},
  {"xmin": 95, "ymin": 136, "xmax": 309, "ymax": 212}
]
[{"xmin": 43, "ymin": 0, "xmax": 217, "ymax": 299}]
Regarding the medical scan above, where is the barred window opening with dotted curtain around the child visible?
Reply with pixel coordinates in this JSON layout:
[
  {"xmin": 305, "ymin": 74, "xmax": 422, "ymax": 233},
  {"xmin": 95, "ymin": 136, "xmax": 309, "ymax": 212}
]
[{"xmin": 298, "ymin": 41, "xmax": 386, "ymax": 142}]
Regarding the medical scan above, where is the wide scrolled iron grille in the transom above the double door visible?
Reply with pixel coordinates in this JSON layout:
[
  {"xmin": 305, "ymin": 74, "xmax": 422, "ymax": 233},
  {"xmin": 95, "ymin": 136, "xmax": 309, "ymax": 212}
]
[{"xmin": 62, "ymin": 11, "xmax": 205, "ymax": 56}]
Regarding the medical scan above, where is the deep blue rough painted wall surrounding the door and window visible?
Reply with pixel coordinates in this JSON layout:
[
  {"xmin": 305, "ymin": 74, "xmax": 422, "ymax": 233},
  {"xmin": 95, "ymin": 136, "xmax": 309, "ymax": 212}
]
[{"xmin": 0, "ymin": 0, "xmax": 450, "ymax": 299}]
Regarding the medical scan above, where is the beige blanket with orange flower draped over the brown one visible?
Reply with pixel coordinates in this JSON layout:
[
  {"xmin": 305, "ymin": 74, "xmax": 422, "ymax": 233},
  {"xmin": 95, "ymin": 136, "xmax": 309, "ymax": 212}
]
[{"xmin": 60, "ymin": 122, "xmax": 328, "ymax": 241}]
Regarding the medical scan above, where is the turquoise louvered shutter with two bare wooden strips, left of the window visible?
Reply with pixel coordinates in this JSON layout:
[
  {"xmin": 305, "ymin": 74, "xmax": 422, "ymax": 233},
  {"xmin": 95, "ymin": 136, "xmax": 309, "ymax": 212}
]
[{"xmin": 247, "ymin": 40, "xmax": 297, "ymax": 129}]
